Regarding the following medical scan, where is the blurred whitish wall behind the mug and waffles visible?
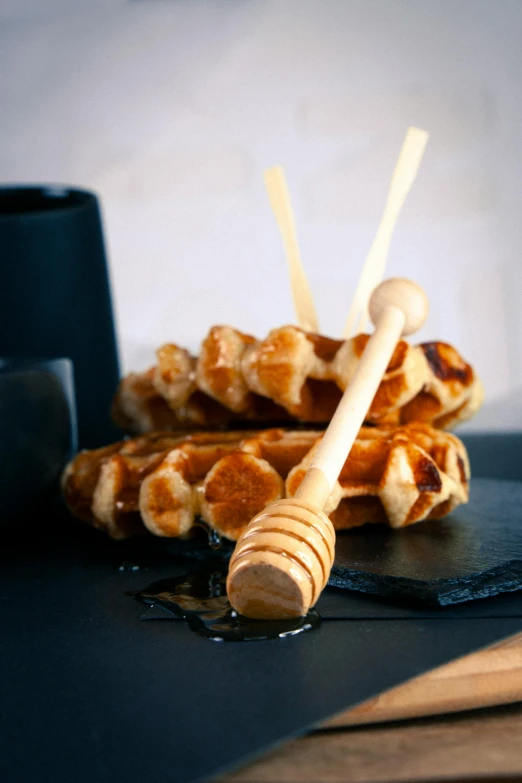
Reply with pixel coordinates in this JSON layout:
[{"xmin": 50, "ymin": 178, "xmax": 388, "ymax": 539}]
[{"xmin": 0, "ymin": 0, "xmax": 522, "ymax": 429}]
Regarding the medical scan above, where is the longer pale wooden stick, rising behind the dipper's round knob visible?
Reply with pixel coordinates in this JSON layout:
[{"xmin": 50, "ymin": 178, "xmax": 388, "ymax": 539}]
[{"xmin": 343, "ymin": 127, "xmax": 429, "ymax": 338}]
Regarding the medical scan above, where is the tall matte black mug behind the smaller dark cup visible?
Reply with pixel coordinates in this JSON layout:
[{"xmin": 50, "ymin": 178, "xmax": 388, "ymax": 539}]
[{"xmin": 0, "ymin": 186, "xmax": 119, "ymax": 448}]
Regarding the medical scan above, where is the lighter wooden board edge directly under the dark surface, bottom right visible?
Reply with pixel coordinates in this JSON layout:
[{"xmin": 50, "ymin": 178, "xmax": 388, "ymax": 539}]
[{"xmin": 321, "ymin": 633, "xmax": 522, "ymax": 728}]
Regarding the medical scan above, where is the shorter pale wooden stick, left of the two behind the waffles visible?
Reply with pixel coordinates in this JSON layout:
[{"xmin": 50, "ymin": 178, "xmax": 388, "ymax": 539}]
[{"xmin": 265, "ymin": 166, "xmax": 319, "ymax": 332}]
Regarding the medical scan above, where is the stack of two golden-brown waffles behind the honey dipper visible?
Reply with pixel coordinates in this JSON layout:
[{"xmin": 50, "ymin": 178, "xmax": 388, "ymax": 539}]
[{"xmin": 63, "ymin": 326, "xmax": 482, "ymax": 541}]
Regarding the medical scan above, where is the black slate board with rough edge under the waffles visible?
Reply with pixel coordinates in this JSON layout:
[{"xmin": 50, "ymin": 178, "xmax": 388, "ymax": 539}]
[{"xmin": 329, "ymin": 479, "xmax": 522, "ymax": 606}]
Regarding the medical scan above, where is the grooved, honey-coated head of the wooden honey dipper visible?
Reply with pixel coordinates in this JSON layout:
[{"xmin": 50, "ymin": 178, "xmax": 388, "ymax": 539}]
[{"xmin": 227, "ymin": 498, "xmax": 335, "ymax": 620}]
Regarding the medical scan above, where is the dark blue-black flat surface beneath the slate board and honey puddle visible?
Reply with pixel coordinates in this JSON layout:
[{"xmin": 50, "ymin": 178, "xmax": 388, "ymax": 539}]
[{"xmin": 0, "ymin": 436, "xmax": 522, "ymax": 783}]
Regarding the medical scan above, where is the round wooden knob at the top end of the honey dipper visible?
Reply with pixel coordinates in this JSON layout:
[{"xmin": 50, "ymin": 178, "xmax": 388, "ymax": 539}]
[{"xmin": 368, "ymin": 277, "xmax": 429, "ymax": 335}]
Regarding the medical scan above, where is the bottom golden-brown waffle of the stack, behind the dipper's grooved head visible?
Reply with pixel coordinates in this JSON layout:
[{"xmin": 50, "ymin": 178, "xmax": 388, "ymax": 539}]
[{"xmin": 63, "ymin": 424, "xmax": 469, "ymax": 541}]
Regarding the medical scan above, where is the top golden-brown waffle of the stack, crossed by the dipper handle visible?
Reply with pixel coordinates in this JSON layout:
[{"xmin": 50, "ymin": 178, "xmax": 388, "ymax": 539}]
[{"xmin": 113, "ymin": 326, "xmax": 483, "ymax": 432}]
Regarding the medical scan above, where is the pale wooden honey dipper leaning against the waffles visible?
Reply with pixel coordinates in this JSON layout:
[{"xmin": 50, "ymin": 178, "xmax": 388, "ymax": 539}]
[{"xmin": 227, "ymin": 278, "xmax": 428, "ymax": 620}]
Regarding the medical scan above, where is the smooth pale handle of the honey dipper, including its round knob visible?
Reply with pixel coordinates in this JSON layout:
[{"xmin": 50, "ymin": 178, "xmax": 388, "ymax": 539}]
[{"xmin": 295, "ymin": 278, "xmax": 428, "ymax": 509}]
